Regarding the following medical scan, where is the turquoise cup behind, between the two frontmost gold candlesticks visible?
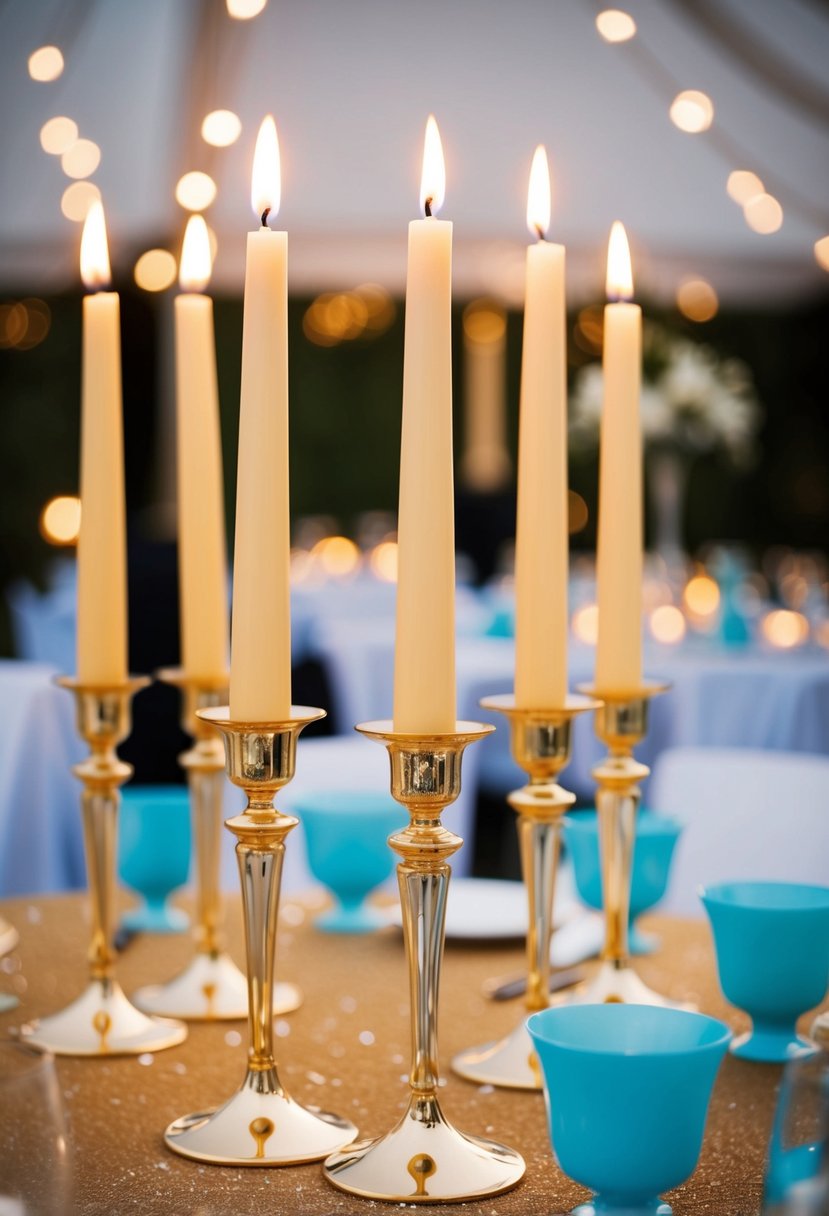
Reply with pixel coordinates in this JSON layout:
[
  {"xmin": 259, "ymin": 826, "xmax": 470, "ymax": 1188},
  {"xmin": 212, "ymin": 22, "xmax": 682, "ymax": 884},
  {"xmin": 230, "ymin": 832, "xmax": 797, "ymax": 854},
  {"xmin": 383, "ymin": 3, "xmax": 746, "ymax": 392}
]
[{"xmin": 291, "ymin": 789, "xmax": 406, "ymax": 933}]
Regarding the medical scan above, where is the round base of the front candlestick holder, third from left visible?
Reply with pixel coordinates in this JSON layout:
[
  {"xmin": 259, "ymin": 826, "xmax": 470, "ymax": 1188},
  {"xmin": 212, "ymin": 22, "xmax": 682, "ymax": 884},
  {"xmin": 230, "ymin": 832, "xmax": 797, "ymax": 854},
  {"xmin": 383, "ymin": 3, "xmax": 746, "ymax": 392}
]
[{"xmin": 164, "ymin": 1069, "xmax": 357, "ymax": 1165}]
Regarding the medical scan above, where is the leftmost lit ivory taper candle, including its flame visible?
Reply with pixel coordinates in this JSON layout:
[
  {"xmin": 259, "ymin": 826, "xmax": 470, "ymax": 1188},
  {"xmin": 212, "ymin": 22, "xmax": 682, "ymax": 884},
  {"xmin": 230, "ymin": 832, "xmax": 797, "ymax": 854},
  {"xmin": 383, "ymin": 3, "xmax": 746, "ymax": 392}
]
[{"xmin": 77, "ymin": 202, "xmax": 126, "ymax": 685}]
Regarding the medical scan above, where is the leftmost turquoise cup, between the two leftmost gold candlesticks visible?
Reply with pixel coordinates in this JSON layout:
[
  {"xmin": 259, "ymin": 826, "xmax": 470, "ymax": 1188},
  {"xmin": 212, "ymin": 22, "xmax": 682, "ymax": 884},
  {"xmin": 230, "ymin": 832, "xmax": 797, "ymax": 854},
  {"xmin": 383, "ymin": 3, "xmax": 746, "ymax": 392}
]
[{"xmin": 118, "ymin": 786, "xmax": 191, "ymax": 933}]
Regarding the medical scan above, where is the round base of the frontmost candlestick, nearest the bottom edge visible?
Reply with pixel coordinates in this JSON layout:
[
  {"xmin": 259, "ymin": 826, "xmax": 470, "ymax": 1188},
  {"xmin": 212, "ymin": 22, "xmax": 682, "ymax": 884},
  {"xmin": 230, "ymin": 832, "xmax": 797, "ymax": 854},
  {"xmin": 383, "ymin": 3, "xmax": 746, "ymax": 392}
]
[{"xmin": 325, "ymin": 1093, "xmax": 525, "ymax": 1204}]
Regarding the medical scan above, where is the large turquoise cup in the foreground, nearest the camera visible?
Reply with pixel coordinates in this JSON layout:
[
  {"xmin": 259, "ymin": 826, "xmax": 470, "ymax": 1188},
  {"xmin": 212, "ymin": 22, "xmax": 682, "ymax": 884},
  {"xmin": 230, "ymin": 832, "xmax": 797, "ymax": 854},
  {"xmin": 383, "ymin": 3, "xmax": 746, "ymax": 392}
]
[{"xmin": 528, "ymin": 1004, "xmax": 731, "ymax": 1216}]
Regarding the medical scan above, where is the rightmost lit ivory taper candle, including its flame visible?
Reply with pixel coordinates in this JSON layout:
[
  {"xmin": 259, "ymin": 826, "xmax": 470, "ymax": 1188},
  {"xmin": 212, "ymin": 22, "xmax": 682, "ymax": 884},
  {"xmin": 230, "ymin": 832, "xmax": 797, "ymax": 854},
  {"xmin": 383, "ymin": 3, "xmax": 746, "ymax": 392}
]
[{"xmin": 596, "ymin": 221, "xmax": 642, "ymax": 696}]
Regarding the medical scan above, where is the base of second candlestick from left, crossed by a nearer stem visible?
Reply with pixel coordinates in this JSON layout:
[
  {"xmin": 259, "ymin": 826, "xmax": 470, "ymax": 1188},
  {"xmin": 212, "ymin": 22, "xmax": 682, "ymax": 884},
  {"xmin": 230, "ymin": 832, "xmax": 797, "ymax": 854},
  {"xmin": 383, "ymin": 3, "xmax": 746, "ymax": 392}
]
[{"xmin": 132, "ymin": 953, "xmax": 303, "ymax": 1021}]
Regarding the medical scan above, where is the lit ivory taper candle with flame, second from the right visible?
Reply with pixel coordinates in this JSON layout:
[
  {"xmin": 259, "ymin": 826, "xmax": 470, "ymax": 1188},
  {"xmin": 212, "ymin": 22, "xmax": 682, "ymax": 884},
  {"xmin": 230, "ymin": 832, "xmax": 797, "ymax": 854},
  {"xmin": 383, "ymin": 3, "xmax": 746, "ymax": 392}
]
[{"xmin": 515, "ymin": 147, "xmax": 568, "ymax": 709}]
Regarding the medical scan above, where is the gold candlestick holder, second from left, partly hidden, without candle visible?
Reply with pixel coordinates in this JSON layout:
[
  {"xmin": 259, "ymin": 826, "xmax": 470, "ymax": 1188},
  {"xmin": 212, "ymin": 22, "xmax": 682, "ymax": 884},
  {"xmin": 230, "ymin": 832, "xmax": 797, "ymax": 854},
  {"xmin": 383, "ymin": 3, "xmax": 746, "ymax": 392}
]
[{"xmin": 132, "ymin": 668, "xmax": 303, "ymax": 1021}]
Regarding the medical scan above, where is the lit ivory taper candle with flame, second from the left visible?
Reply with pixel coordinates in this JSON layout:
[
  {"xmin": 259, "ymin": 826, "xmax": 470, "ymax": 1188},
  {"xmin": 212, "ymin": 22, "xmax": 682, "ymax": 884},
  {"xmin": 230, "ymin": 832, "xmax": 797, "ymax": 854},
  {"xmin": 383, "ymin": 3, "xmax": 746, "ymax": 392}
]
[{"xmin": 175, "ymin": 215, "xmax": 229, "ymax": 680}]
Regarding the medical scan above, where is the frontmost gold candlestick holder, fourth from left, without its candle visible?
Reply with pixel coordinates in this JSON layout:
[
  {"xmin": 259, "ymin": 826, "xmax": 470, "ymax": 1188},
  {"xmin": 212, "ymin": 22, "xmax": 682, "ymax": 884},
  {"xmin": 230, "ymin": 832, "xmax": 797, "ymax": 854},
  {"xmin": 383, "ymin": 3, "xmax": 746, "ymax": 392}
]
[{"xmin": 323, "ymin": 721, "xmax": 525, "ymax": 1204}]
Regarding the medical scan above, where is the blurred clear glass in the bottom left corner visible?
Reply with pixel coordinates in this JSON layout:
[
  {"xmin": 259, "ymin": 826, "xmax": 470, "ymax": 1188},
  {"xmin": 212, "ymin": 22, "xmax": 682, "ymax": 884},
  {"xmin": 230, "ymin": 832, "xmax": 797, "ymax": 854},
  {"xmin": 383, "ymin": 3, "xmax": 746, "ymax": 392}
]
[{"xmin": 0, "ymin": 1042, "xmax": 72, "ymax": 1216}]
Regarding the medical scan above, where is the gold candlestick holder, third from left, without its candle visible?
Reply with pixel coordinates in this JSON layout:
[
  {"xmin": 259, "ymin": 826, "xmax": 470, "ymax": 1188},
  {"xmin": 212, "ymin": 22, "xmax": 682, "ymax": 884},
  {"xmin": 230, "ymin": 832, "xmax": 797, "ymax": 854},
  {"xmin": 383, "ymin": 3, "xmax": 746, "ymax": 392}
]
[{"xmin": 164, "ymin": 705, "xmax": 357, "ymax": 1165}]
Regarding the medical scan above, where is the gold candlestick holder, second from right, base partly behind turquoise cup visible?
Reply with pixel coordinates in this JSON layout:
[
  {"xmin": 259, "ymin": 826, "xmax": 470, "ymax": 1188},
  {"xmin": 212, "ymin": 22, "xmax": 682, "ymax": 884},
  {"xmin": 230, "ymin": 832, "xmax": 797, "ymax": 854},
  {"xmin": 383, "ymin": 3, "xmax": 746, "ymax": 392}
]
[{"xmin": 452, "ymin": 693, "xmax": 598, "ymax": 1090}]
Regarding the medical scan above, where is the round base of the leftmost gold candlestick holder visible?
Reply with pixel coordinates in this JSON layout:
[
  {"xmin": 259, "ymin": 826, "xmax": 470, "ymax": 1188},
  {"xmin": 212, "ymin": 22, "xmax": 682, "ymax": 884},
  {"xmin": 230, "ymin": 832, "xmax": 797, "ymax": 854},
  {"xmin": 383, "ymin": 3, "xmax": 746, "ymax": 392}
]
[{"xmin": 21, "ymin": 978, "xmax": 187, "ymax": 1055}]
